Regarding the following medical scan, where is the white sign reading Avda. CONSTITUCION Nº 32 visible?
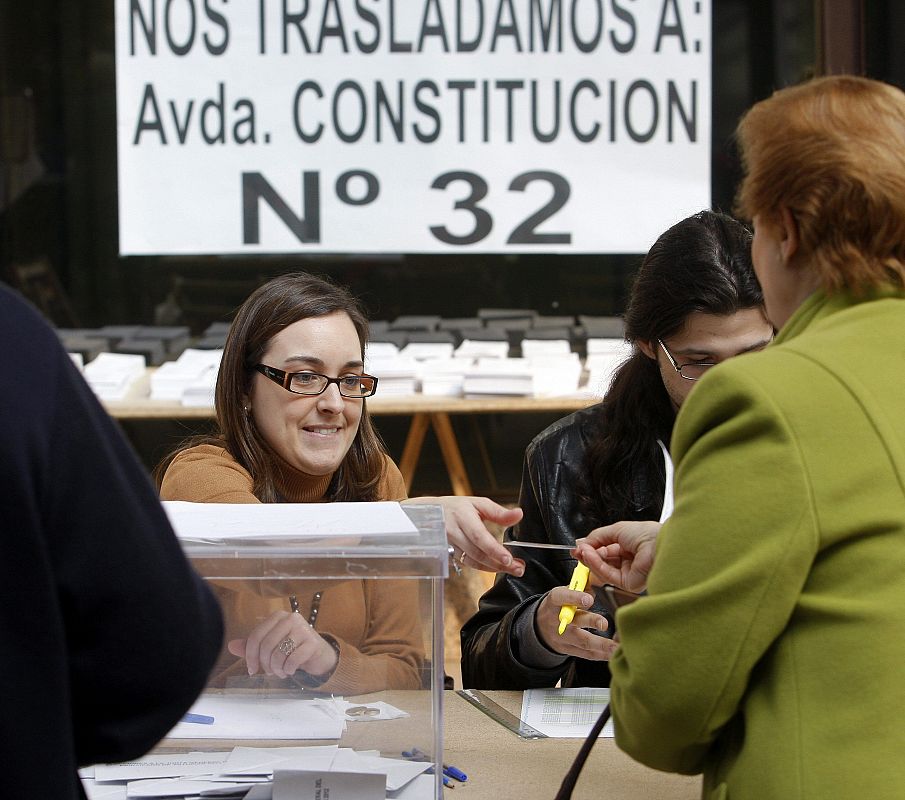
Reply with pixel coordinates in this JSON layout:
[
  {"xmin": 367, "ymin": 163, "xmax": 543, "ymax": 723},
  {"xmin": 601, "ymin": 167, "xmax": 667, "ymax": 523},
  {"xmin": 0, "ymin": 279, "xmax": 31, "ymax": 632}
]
[{"xmin": 116, "ymin": 0, "xmax": 711, "ymax": 255}]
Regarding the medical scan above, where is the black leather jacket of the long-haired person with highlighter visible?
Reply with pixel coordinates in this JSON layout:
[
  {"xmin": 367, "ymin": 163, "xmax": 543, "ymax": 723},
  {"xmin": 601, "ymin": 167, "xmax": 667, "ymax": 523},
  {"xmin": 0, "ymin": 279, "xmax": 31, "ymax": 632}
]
[{"xmin": 461, "ymin": 406, "xmax": 662, "ymax": 689}]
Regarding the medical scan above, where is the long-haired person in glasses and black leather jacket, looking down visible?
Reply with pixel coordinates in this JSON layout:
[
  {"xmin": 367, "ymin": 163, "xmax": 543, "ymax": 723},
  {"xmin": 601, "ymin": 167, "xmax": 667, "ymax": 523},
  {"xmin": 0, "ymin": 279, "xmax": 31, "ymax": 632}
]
[{"xmin": 461, "ymin": 211, "xmax": 773, "ymax": 689}]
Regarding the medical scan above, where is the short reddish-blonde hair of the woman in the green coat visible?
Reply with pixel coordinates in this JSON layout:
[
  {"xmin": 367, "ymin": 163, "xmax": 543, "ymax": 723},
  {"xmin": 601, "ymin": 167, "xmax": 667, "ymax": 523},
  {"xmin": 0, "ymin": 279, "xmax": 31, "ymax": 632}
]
[{"xmin": 737, "ymin": 75, "xmax": 905, "ymax": 293}]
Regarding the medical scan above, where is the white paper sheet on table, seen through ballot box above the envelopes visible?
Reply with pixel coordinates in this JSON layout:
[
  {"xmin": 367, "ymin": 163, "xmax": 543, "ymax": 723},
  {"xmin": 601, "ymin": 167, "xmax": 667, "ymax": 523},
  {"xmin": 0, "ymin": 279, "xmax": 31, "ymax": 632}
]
[{"xmin": 167, "ymin": 694, "xmax": 346, "ymax": 739}]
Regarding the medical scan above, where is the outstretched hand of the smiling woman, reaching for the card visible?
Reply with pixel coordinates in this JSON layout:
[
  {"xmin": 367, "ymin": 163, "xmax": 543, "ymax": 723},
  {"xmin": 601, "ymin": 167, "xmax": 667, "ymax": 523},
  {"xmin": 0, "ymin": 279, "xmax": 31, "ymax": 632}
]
[{"xmin": 403, "ymin": 495, "xmax": 525, "ymax": 578}]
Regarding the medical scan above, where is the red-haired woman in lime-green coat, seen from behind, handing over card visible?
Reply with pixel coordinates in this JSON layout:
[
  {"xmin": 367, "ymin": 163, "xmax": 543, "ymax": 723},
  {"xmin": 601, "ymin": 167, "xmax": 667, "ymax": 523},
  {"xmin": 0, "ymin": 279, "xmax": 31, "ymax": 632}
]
[{"xmin": 579, "ymin": 76, "xmax": 905, "ymax": 800}]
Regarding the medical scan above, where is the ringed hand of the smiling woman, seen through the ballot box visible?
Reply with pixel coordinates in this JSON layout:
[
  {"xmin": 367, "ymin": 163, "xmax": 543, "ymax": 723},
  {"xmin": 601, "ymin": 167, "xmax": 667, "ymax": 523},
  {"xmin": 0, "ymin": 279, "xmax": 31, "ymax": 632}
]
[{"xmin": 227, "ymin": 611, "xmax": 339, "ymax": 679}]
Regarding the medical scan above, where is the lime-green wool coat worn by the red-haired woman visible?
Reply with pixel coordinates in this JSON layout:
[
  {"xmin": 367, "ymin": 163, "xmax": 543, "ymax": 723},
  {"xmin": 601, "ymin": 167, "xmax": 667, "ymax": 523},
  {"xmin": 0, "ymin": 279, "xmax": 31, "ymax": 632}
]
[{"xmin": 611, "ymin": 284, "xmax": 905, "ymax": 800}]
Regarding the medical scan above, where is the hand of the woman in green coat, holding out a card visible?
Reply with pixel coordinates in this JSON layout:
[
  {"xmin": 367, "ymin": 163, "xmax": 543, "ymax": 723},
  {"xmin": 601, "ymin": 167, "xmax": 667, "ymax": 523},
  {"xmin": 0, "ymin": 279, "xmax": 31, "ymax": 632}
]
[{"xmin": 575, "ymin": 521, "xmax": 662, "ymax": 592}]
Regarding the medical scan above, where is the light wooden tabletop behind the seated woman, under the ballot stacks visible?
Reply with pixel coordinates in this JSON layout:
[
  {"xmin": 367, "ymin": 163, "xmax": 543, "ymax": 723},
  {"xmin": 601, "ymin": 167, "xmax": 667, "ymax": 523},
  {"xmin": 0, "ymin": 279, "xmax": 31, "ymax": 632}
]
[{"xmin": 104, "ymin": 368, "xmax": 600, "ymax": 420}]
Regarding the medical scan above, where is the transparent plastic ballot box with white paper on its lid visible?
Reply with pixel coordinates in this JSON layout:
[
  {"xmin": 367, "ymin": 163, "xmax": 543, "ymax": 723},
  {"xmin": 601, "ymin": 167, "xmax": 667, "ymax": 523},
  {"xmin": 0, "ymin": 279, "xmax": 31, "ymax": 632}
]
[{"xmin": 158, "ymin": 503, "xmax": 448, "ymax": 798}]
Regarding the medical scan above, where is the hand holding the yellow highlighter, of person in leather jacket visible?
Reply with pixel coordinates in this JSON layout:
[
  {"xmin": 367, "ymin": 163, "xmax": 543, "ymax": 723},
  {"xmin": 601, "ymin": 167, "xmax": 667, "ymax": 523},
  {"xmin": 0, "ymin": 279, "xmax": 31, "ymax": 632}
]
[{"xmin": 534, "ymin": 586, "xmax": 618, "ymax": 661}]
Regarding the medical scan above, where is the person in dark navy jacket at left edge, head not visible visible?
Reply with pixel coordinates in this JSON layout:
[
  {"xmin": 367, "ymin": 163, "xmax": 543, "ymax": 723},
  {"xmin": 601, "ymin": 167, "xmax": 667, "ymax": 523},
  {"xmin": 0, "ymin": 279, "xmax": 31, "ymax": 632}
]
[{"xmin": 0, "ymin": 286, "xmax": 222, "ymax": 800}]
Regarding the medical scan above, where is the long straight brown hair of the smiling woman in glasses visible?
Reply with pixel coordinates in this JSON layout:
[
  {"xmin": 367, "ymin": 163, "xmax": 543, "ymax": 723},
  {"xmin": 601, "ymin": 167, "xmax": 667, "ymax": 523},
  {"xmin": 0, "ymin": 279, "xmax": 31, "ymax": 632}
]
[{"xmin": 155, "ymin": 272, "xmax": 386, "ymax": 503}]
